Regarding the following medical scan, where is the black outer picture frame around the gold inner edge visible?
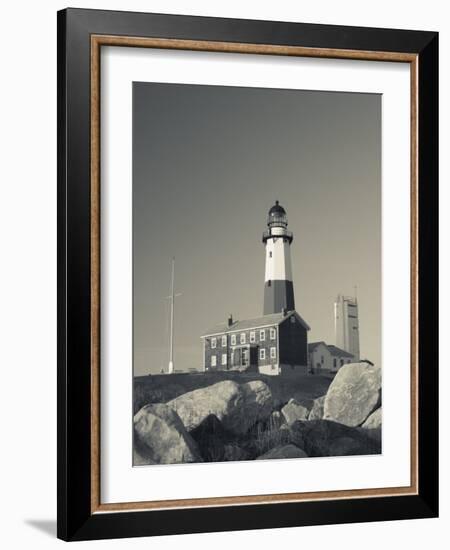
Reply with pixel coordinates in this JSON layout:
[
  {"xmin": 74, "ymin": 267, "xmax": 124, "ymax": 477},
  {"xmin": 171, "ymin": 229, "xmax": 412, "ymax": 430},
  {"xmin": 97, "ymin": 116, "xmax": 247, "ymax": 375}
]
[{"xmin": 57, "ymin": 9, "xmax": 438, "ymax": 540}]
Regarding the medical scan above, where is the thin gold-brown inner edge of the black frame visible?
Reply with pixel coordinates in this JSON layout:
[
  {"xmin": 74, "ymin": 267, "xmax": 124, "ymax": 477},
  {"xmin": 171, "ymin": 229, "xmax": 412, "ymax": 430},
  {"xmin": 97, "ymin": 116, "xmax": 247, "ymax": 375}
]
[{"xmin": 90, "ymin": 34, "xmax": 419, "ymax": 514}]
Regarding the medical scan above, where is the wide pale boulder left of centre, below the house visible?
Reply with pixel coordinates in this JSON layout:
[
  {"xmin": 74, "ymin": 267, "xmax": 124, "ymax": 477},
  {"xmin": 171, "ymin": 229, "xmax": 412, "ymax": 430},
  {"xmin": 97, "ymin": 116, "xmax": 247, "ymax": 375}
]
[{"xmin": 167, "ymin": 380, "xmax": 273, "ymax": 435}]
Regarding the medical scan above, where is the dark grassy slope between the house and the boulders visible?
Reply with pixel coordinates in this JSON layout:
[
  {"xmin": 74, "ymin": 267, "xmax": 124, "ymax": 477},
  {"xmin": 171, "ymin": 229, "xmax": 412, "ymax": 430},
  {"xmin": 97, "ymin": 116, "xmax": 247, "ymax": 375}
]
[{"xmin": 133, "ymin": 372, "xmax": 332, "ymax": 413}]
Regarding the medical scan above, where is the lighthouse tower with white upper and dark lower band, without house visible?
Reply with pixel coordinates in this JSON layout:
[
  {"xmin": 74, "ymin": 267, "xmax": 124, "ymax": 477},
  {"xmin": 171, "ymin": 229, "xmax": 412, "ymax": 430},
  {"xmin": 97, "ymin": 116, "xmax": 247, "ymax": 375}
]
[{"xmin": 262, "ymin": 201, "xmax": 295, "ymax": 315}]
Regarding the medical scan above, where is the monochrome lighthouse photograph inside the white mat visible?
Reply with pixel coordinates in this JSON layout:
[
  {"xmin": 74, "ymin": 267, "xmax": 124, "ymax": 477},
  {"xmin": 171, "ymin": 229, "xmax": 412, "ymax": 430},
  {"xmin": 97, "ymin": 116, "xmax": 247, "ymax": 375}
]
[{"xmin": 130, "ymin": 81, "xmax": 383, "ymax": 467}]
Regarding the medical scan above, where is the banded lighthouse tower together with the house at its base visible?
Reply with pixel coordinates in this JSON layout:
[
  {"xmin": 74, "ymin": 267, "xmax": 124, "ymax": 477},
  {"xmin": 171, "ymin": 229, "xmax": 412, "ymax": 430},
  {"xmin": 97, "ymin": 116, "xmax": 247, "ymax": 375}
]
[{"xmin": 201, "ymin": 201, "xmax": 310, "ymax": 376}]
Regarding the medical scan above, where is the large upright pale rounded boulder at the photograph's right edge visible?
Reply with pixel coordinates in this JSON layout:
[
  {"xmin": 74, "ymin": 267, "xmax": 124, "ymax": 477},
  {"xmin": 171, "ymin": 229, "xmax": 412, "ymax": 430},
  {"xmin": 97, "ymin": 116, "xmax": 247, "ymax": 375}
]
[{"xmin": 323, "ymin": 363, "xmax": 381, "ymax": 426}]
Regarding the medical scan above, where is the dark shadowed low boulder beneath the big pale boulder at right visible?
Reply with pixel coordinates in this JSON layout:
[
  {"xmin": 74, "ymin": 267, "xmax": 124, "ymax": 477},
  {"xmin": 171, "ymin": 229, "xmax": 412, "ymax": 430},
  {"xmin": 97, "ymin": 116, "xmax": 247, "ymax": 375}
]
[{"xmin": 290, "ymin": 420, "xmax": 381, "ymax": 456}]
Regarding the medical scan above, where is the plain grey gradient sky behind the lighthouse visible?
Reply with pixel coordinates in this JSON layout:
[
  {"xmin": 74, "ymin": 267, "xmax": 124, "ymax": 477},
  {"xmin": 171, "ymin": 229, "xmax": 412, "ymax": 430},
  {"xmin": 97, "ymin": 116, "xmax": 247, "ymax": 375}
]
[{"xmin": 133, "ymin": 82, "xmax": 381, "ymax": 375}]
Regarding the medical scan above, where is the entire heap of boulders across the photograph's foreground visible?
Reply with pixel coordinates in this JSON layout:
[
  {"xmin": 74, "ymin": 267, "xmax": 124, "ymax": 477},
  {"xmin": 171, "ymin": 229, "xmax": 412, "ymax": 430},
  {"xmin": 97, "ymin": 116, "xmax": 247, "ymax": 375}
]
[{"xmin": 134, "ymin": 363, "xmax": 382, "ymax": 466}]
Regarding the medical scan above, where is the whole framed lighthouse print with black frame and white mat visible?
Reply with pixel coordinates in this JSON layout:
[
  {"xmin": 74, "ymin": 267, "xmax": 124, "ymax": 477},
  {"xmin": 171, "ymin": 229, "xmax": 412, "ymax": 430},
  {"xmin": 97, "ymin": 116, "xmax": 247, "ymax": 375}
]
[{"xmin": 58, "ymin": 9, "xmax": 438, "ymax": 540}]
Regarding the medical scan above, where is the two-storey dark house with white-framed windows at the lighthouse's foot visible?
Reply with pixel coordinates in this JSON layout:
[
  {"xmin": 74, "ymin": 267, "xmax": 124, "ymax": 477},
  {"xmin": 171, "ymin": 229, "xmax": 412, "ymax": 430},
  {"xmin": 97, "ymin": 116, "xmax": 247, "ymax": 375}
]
[{"xmin": 201, "ymin": 309, "xmax": 309, "ymax": 375}]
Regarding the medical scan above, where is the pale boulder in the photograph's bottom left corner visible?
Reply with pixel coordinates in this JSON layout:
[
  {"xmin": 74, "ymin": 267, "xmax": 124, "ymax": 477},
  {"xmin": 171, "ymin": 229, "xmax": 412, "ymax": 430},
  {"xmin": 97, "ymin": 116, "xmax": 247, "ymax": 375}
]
[{"xmin": 134, "ymin": 403, "xmax": 202, "ymax": 464}]
